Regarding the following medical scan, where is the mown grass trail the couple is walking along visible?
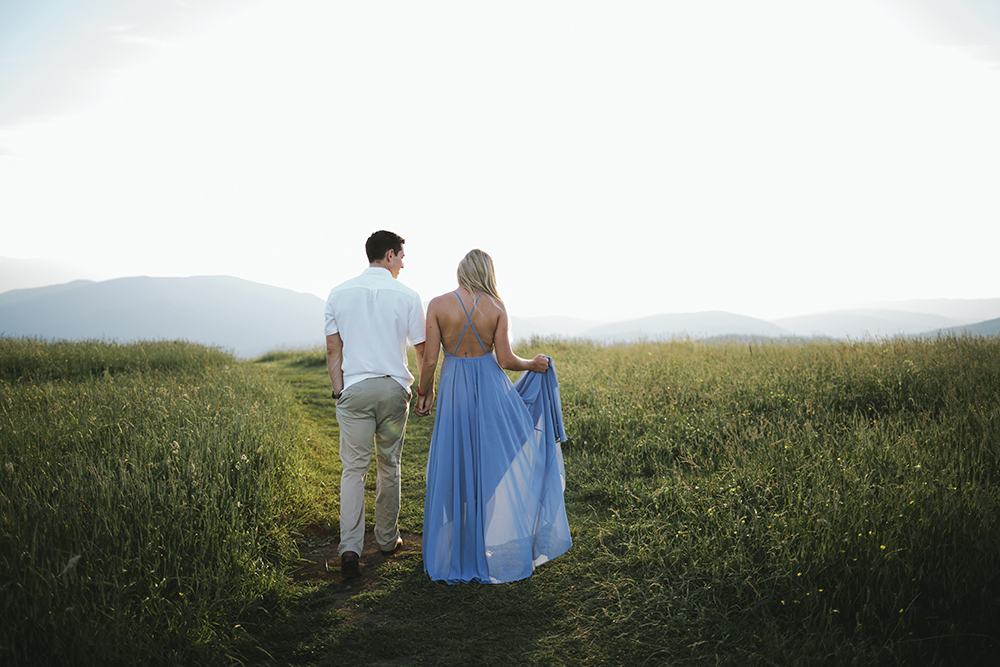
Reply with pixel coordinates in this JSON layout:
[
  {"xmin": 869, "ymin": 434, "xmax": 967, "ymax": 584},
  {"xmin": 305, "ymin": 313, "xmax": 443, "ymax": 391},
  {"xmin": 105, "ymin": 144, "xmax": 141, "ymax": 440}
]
[{"xmin": 247, "ymin": 350, "xmax": 572, "ymax": 665}]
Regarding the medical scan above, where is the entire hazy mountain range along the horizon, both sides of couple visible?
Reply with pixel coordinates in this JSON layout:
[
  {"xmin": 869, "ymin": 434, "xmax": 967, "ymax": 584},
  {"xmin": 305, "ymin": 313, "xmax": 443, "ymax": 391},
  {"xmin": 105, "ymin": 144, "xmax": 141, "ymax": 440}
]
[{"xmin": 0, "ymin": 258, "xmax": 1000, "ymax": 358}]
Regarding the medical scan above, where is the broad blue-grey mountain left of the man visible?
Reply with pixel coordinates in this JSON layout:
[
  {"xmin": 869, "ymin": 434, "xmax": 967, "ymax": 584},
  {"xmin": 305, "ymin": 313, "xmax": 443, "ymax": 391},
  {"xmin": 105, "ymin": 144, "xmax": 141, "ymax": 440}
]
[{"xmin": 0, "ymin": 276, "xmax": 323, "ymax": 358}]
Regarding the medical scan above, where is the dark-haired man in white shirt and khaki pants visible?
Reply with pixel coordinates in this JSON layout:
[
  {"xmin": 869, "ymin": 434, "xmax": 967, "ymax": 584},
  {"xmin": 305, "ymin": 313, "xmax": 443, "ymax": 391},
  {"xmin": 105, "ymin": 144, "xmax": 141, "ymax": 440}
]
[{"xmin": 326, "ymin": 230, "xmax": 425, "ymax": 579}]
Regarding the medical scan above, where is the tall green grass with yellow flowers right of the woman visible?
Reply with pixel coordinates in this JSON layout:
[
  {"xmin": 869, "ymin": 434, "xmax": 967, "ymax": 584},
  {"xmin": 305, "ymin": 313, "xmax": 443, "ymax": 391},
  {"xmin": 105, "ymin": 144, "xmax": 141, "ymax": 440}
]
[{"xmin": 542, "ymin": 338, "xmax": 1000, "ymax": 664}]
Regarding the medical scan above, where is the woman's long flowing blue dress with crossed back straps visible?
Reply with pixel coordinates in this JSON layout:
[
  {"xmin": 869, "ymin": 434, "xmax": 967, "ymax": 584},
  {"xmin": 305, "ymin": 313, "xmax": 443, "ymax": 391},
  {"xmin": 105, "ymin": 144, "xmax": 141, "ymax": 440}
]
[{"xmin": 423, "ymin": 296, "xmax": 572, "ymax": 584}]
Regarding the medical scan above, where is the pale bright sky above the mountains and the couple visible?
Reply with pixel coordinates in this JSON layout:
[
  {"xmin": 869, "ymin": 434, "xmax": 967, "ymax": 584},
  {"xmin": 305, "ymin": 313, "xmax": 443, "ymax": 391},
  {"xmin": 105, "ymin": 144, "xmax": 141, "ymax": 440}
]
[{"xmin": 0, "ymin": 0, "xmax": 1000, "ymax": 320}]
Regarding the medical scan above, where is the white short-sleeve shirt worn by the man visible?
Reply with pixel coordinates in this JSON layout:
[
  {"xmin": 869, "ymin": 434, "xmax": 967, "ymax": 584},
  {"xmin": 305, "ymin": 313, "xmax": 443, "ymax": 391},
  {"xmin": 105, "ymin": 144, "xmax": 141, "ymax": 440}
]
[{"xmin": 325, "ymin": 266, "xmax": 427, "ymax": 392}]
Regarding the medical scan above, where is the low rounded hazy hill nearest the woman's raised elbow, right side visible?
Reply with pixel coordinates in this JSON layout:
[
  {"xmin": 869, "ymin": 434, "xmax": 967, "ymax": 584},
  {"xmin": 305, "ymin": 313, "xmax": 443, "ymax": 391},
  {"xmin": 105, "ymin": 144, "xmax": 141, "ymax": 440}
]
[{"xmin": 580, "ymin": 310, "xmax": 791, "ymax": 342}]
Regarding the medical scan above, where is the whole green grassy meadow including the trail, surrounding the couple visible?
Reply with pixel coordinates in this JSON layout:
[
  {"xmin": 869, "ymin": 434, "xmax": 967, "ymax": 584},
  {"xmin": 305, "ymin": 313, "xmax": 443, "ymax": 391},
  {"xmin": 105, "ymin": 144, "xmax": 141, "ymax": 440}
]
[{"xmin": 0, "ymin": 338, "xmax": 1000, "ymax": 666}]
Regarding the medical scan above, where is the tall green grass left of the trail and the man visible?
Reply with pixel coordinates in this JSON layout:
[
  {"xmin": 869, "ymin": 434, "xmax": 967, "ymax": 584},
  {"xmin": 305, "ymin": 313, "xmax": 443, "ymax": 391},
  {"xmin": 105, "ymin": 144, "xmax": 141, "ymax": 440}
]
[{"xmin": 0, "ymin": 339, "xmax": 304, "ymax": 664}]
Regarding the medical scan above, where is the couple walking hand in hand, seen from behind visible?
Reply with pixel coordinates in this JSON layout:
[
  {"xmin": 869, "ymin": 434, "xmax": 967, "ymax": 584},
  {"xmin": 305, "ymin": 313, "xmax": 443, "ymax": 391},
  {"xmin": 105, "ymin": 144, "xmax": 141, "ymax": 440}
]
[{"xmin": 326, "ymin": 231, "xmax": 572, "ymax": 583}]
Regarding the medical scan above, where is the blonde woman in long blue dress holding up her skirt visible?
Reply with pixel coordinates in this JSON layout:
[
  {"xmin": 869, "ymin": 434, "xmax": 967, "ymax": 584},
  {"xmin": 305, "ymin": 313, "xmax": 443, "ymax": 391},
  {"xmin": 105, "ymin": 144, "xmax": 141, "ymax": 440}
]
[{"xmin": 415, "ymin": 250, "xmax": 572, "ymax": 583}]
